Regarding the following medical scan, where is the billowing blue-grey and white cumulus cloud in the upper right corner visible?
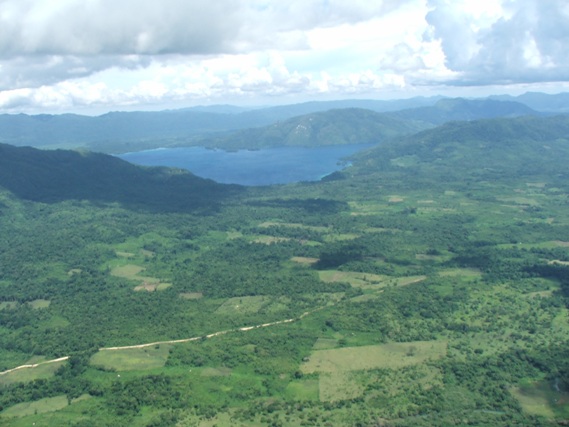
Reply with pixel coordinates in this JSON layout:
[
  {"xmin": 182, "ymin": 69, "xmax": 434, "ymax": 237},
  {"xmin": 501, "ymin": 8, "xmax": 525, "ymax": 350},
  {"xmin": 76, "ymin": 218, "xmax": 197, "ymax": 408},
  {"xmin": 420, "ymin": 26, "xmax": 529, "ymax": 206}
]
[{"xmin": 426, "ymin": 0, "xmax": 569, "ymax": 84}]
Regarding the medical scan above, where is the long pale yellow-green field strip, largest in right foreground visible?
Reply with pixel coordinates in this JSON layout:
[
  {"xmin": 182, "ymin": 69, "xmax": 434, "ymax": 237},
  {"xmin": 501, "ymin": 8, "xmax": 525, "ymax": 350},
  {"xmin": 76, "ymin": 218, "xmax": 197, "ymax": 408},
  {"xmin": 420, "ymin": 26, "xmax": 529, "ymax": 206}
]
[{"xmin": 301, "ymin": 341, "xmax": 447, "ymax": 374}]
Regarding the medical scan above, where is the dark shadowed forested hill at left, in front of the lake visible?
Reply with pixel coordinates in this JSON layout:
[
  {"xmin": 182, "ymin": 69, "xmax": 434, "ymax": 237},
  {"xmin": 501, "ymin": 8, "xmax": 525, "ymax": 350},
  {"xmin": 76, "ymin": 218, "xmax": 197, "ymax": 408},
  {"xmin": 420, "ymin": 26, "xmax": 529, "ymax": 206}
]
[{"xmin": 0, "ymin": 144, "xmax": 237, "ymax": 210}]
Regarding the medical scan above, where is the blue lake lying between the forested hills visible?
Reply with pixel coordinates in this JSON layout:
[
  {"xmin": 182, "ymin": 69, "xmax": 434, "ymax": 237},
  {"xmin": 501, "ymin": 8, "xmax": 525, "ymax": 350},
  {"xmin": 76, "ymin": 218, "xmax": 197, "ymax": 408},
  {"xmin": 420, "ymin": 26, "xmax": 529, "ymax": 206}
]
[{"xmin": 118, "ymin": 144, "xmax": 372, "ymax": 186}]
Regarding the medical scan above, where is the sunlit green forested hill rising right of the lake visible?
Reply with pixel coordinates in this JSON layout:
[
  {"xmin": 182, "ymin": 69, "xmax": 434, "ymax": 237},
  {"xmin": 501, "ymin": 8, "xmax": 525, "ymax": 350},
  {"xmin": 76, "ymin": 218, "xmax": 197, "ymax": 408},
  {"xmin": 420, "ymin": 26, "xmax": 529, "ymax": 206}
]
[{"xmin": 349, "ymin": 116, "xmax": 569, "ymax": 185}]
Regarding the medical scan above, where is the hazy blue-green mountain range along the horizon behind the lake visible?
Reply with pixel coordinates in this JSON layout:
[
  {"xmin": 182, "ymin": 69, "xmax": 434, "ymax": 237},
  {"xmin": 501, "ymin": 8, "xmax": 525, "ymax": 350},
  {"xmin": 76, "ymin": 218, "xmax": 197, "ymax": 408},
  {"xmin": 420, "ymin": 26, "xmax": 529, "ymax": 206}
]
[{"xmin": 0, "ymin": 93, "xmax": 569, "ymax": 153}]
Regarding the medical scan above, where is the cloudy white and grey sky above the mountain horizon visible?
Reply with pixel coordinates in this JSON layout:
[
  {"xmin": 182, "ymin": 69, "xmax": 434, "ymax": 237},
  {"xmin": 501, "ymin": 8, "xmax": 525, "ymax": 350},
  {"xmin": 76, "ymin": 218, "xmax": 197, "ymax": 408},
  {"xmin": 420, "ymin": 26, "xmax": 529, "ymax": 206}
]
[{"xmin": 0, "ymin": 0, "xmax": 569, "ymax": 114}]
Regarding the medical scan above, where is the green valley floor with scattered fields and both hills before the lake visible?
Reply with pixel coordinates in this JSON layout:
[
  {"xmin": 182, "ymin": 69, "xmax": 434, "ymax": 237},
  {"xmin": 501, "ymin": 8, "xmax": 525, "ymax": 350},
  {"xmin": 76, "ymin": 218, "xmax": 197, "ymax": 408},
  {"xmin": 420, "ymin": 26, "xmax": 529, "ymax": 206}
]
[{"xmin": 0, "ymin": 112, "xmax": 569, "ymax": 426}]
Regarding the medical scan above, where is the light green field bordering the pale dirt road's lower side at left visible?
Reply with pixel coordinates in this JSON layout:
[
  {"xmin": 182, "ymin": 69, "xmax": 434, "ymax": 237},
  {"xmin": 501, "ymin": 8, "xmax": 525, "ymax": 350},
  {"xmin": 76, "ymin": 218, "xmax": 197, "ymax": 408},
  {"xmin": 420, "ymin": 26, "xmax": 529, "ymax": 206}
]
[{"xmin": 90, "ymin": 344, "xmax": 172, "ymax": 371}]
